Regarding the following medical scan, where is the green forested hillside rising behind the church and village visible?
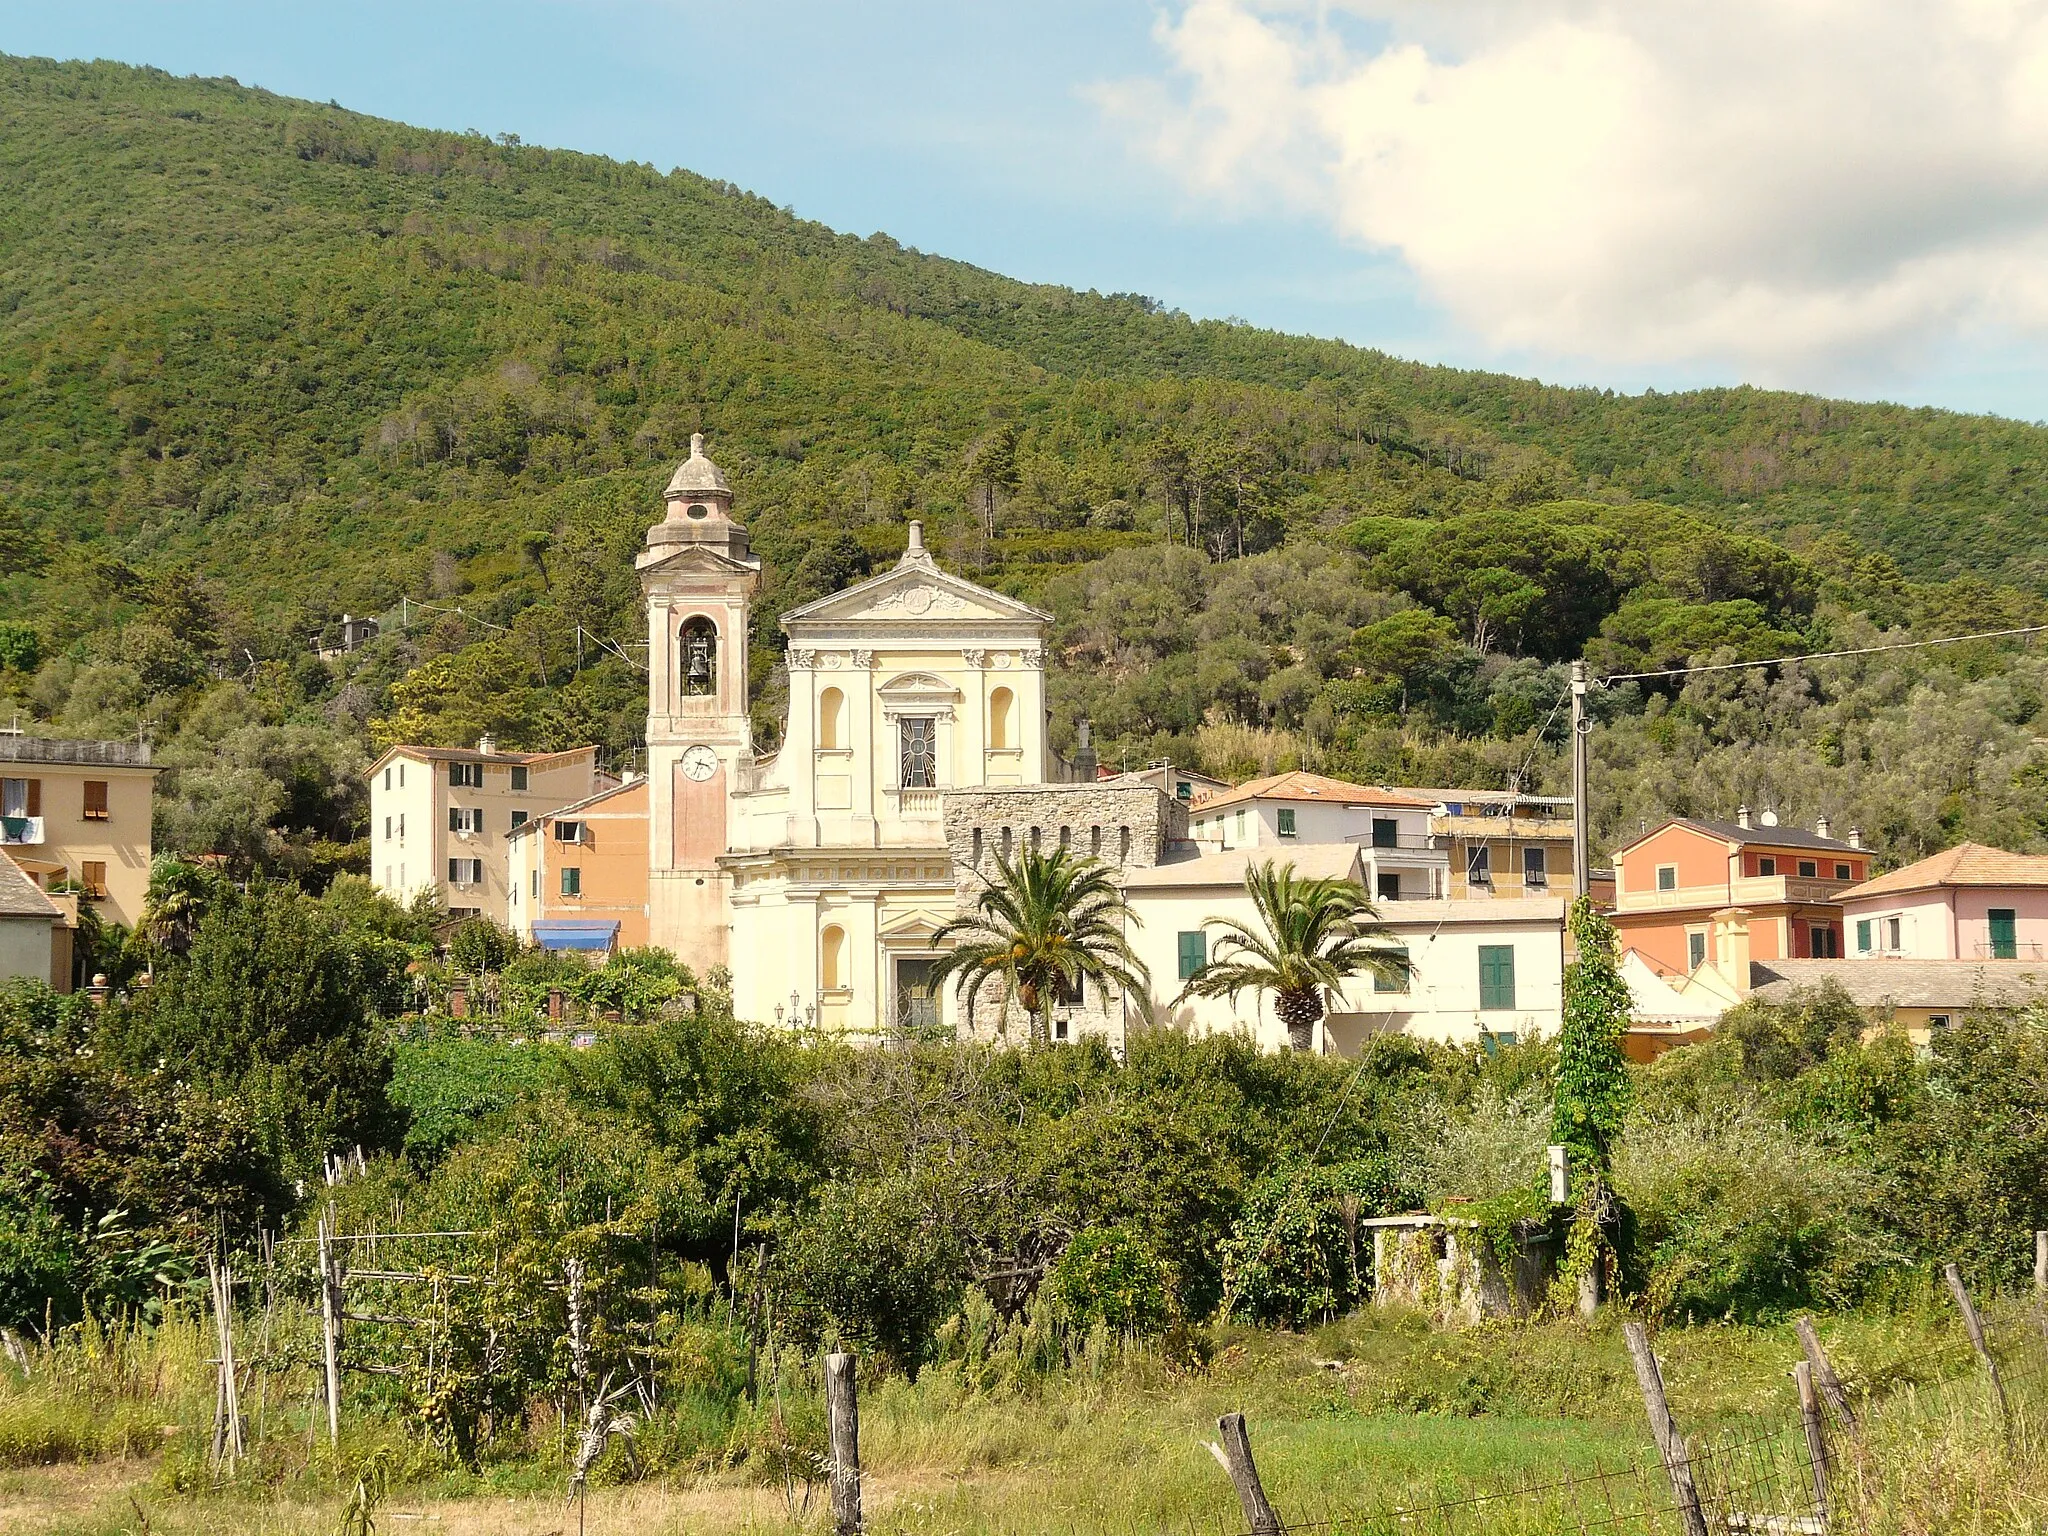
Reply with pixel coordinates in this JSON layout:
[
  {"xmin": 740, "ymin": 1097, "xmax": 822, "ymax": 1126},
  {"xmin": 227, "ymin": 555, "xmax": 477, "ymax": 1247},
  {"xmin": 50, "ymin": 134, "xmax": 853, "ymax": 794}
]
[{"xmin": 0, "ymin": 59, "xmax": 2048, "ymax": 874}]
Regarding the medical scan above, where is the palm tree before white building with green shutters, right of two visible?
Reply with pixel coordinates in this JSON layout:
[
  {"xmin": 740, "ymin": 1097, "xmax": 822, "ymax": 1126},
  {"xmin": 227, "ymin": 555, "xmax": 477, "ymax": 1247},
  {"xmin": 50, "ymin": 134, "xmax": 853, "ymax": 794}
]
[{"xmin": 1176, "ymin": 860, "xmax": 1409, "ymax": 1051}]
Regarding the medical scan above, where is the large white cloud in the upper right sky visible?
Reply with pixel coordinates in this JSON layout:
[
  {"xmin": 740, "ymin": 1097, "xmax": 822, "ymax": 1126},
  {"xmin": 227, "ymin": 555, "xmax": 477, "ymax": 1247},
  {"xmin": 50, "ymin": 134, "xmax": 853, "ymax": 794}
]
[{"xmin": 1098, "ymin": 0, "xmax": 2048, "ymax": 379}]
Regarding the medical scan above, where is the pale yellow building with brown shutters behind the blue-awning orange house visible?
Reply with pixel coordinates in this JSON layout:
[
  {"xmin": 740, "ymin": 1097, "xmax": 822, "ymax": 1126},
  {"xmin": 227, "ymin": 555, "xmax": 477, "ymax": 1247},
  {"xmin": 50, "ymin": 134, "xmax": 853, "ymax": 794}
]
[{"xmin": 371, "ymin": 737, "xmax": 610, "ymax": 926}]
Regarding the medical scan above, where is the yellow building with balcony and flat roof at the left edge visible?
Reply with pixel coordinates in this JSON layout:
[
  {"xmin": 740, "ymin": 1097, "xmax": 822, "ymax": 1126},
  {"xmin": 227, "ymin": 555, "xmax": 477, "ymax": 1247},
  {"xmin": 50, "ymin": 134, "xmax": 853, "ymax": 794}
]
[{"xmin": 0, "ymin": 731, "xmax": 160, "ymax": 928}]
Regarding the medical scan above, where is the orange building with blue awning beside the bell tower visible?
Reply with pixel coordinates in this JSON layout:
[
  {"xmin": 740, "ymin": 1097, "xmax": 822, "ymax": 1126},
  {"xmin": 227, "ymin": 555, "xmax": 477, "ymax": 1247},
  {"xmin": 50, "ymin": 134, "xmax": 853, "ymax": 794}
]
[{"xmin": 506, "ymin": 778, "xmax": 647, "ymax": 950}]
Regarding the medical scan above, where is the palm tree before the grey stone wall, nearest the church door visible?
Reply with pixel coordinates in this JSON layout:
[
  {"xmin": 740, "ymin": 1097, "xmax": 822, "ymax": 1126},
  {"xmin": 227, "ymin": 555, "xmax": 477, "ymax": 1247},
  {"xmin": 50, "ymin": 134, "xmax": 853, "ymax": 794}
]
[{"xmin": 932, "ymin": 848, "xmax": 1151, "ymax": 1044}]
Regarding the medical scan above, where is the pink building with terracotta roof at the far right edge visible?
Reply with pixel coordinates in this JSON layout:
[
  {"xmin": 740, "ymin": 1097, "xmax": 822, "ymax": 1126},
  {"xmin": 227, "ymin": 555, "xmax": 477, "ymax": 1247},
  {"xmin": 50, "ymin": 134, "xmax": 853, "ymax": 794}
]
[{"xmin": 1835, "ymin": 842, "xmax": 2048, "ymax": 961}]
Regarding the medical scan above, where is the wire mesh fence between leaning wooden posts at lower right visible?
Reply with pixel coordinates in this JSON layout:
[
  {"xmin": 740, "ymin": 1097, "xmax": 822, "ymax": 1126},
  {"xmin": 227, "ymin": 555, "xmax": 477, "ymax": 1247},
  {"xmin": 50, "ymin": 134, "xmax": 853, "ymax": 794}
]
[{"xmin": 1188, "ymin": 1307, "xmax": 2048, "ymax": 1536}]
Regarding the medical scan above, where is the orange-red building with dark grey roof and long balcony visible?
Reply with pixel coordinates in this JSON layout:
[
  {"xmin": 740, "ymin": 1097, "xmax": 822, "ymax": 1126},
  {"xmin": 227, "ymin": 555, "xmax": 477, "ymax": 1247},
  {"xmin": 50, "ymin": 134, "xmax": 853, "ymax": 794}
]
[{"xmin": 1612, "ymin": 807, "xmax": 1870, "ymax": 975}]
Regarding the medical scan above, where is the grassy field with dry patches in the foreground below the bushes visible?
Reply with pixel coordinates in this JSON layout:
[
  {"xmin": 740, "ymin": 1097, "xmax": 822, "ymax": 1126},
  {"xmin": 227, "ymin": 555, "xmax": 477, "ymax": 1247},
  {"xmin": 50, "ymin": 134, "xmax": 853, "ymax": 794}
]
[{"xmin": 0, "ymin": 1309, "xmax": 2048, "ymax": 1536}]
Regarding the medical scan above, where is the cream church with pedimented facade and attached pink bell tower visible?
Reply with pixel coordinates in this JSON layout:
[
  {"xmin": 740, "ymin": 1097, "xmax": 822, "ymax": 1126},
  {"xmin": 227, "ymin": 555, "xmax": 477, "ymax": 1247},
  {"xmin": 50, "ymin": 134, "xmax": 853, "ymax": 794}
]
[{"xmin": 637, "ymin": 438, "xmax": 1138, "ymax": 1036}]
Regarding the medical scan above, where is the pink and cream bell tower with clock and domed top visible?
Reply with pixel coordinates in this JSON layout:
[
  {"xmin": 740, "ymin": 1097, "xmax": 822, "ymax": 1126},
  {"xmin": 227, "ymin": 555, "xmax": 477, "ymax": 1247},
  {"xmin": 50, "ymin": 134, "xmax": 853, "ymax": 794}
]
[{"xmin": 633, "ymin": 432, "xmax": 762, "ymax": 975}]
